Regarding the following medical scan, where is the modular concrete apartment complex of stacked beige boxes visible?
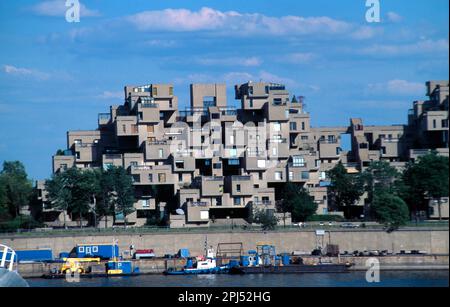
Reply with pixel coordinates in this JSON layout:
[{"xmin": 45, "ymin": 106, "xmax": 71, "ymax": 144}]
[{"xmin": 38, "ymin": 81, "xmax": 449, "ymax": 227}]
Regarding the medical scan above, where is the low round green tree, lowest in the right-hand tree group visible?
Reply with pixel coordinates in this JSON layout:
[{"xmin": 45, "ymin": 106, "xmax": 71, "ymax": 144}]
[{"xmin": 372, "ymin": 193, "xmax": 409, "ymax": 231}]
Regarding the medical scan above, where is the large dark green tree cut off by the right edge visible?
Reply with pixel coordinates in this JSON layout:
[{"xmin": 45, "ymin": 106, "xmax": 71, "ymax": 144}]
[{"xmin": 403, "ymin": 151, "xmax": 449, "ymax": 219}]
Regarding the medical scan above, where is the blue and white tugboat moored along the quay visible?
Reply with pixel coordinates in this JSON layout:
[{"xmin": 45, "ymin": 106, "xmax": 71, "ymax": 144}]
[{"xmin": 164, "ymin": 248, "xmax": 229, "ymax": 275}]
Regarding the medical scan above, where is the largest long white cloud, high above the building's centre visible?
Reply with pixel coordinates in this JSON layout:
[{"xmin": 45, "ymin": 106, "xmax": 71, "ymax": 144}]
[{"xmin": 126, "ymin": 7, "xmax": 354, "ymax": 35}]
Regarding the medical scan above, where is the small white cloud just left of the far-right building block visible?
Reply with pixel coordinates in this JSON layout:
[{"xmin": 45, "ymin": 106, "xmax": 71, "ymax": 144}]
[{"xmin": 366, "ymin": 79, "xmax": 425, "ymax": 96}]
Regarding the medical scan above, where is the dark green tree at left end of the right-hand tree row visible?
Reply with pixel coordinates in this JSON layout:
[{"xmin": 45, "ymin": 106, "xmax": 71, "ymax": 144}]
[{"xmin": 327, "ymin": 162, "xmax": 364, "ymax": 217}]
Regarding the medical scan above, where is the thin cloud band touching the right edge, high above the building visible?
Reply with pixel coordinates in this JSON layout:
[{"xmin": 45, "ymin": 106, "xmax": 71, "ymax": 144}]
[{"xmin": 358, "ymin": 39, "xmax": 449, "ymax": 56}]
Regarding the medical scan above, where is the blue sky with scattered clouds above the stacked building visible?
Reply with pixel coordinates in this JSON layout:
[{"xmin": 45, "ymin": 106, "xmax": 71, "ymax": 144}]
[{"xmin": 0, "ymin": 0, "xmax": 449, "ymax": 179}]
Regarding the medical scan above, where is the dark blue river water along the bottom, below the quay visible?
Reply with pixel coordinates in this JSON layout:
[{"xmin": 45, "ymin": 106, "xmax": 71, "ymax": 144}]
[{"xmin": 27, "ymin": 270, "xmax": 449, "ymax": 287}]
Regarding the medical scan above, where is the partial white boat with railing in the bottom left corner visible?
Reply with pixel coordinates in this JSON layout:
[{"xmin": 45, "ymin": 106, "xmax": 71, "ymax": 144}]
[{"xmin": 0, "ymin": 244, "xmax": 29, "ymax": 287}]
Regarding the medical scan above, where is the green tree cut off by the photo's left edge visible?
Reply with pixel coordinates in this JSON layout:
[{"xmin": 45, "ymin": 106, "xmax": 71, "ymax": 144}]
[{"xmin": 0, "ymin": 161, "xmax": 33, "ymax": 218}]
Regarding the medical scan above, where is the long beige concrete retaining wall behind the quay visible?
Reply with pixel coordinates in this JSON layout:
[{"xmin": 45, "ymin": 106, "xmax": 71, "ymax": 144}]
[{"xmin": 0, "ymin": 229, "xmax": 449, "ymax": 256}]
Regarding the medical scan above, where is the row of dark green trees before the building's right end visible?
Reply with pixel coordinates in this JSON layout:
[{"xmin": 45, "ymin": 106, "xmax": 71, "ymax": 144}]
[{"xmin": 328, "ymin": 152, "xmax": 449, "ymax": 228}]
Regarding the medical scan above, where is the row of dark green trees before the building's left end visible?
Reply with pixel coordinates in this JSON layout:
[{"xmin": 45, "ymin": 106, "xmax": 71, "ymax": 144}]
[{"xmin": 45, "ymin": 166, "xmax": 135, "ymax": 227}]
